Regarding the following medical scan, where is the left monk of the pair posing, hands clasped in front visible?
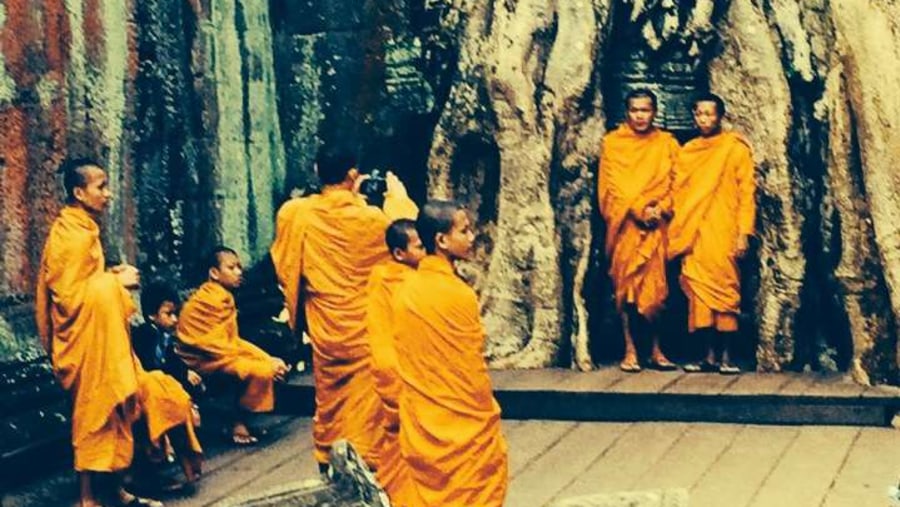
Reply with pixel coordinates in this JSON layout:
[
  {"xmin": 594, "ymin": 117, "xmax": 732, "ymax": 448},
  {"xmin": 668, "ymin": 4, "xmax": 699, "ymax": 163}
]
[{"xmin": 598, "ymin": 89, "xmax": 678, "ymax": 373}]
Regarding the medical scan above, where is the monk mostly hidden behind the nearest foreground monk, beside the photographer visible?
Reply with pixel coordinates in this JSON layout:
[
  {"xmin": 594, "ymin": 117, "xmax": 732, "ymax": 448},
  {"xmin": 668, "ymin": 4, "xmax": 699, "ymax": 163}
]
[{"xmin": 366, "ymin": 218, "xmax": 425, "ymax": 507}]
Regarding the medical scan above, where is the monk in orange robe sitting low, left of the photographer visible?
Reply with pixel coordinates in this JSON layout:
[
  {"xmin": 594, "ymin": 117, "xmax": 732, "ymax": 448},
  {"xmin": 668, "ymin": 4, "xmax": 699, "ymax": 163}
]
[{"xmin": 175, "ymin": 246, "xmax": 288, "ymax": 445}]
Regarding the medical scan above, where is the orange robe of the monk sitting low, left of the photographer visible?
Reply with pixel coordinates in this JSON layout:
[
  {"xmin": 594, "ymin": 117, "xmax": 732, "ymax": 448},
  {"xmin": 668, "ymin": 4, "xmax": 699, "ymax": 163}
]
[{"xmin": 175, "ymin": 282, "xmax": 275, "ymax": 412}]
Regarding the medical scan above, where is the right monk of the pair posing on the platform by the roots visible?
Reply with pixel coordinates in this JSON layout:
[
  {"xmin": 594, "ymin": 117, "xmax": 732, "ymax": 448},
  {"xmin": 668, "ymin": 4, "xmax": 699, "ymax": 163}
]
[{"xmin": 668, "ymin": 94, "xmax": 756, "ymax": 374}]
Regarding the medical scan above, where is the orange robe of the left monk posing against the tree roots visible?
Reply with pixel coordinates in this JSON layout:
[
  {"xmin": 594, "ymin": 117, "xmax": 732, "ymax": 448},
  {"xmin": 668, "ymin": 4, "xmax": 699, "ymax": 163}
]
[{"xmin": 598, "ymin": 125, "xmax": 678, "ymax": 318}]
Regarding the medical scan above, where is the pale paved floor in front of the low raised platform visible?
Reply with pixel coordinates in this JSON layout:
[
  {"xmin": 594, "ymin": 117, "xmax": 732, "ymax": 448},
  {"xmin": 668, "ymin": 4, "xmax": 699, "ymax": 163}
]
[{"xmin": 3, "ymin": 417, "xmax": 900, "ymax": 507}]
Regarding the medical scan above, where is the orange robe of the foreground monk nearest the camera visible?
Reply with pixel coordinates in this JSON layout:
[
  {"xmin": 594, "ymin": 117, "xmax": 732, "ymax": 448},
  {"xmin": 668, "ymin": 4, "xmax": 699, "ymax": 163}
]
[{"xmin": 394, "ymin": 256, "xmax": 508, "ymax": 507}]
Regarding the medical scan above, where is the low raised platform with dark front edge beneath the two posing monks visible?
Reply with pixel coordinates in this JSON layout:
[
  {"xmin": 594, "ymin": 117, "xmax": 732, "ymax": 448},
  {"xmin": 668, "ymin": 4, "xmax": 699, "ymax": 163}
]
[{"xmin": 279, "ymin": 366, "xmax": 900, "ymax": 426}]
